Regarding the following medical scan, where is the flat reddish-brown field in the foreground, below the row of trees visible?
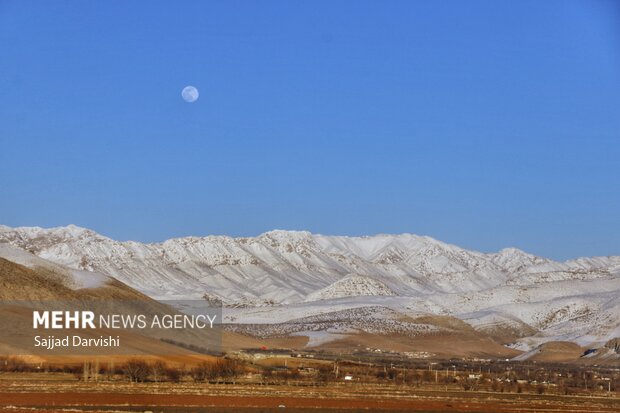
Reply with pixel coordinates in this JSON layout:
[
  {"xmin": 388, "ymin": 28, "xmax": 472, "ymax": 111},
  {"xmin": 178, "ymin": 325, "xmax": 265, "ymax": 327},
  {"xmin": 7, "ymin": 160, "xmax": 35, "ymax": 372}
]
[{"xmin": 0, "ymin": 373, "xmax": 620, "ymax": 413}]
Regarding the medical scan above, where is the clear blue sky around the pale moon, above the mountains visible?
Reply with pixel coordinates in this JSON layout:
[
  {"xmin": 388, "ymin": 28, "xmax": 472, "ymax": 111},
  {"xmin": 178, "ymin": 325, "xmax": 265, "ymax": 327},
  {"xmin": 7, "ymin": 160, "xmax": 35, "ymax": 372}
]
[{"xmin": 0, "ymin": 0, "xmax": 620, "ymax": 259}]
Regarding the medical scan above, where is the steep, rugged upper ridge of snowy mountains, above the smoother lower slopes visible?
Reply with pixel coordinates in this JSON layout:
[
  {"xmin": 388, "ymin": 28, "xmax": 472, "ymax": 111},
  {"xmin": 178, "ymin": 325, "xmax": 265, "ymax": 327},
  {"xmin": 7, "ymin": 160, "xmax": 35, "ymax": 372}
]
[{"xmin": 0, "ymin": 225, "xmax": 620, "ymax": 304}]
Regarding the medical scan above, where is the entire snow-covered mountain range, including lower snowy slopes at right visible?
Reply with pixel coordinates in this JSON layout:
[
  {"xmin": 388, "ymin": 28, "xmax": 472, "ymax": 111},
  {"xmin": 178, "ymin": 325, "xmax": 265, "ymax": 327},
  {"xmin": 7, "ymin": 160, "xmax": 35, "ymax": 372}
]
[{"xmin": 0, "ymin": 225, "xmax": 620, "ymax": 349}]
